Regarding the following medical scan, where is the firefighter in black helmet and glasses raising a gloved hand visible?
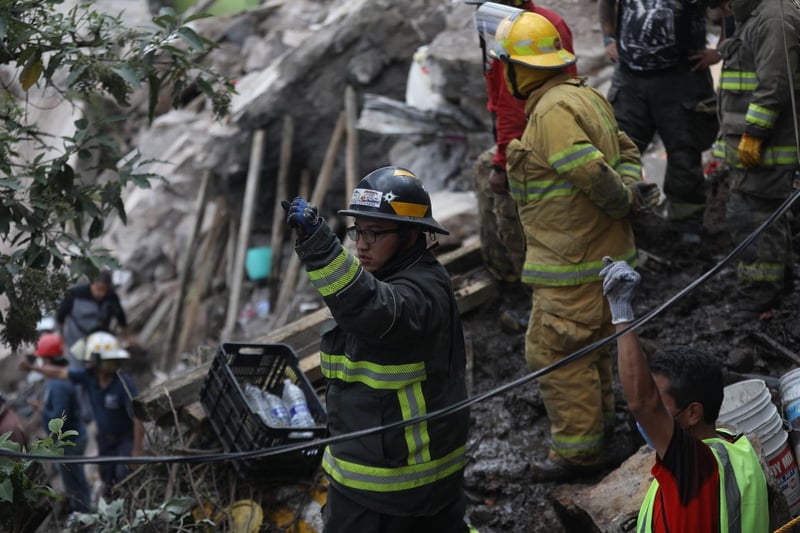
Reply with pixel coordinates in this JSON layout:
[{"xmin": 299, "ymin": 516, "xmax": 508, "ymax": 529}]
[{"xmin": 284, "ymin": 166, "xmax": 469, "ymax": 533}]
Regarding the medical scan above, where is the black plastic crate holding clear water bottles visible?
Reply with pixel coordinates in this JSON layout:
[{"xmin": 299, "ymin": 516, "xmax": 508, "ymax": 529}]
[{"xmin": 200, "ymin": 343, "xmax": 327, "ymax": 481}]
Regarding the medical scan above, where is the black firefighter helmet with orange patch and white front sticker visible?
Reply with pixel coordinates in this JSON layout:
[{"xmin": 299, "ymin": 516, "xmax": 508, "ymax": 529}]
[{"xmin": 339, "ymin": 166, "xmax": 450, "ymax": 235}]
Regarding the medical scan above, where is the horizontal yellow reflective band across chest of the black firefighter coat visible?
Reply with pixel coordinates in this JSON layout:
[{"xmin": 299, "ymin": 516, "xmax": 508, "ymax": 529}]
[{"xmin": 320, "ymin": 352, "xmax": 427, "ymax": 390}]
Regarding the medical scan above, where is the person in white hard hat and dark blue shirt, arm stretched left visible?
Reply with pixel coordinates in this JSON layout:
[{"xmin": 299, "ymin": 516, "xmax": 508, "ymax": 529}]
[{"xmin": 19, "ymin": 331, "xmax": 144, "ymax": 495}]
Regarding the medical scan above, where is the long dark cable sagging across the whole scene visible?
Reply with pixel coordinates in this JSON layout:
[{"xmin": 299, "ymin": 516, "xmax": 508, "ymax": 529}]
[{"xmin": 6, "ymin": 189, "xmax": 800, "ymax": 464}]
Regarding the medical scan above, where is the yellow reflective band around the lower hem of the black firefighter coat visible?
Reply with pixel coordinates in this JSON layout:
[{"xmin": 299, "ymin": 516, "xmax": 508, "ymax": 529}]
[{"xmin": 322, "ymin": 446, "xmax": 465, "ymax": 492}]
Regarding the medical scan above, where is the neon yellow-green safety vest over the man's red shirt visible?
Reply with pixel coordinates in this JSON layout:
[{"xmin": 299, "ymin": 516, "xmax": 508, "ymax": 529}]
[{"xmin": 636, "ymin": 430, "xmax": 769, "ymax": 533}]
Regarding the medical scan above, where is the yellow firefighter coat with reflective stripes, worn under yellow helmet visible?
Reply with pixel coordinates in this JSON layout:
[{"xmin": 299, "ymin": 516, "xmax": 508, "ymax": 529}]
[{"xmin": 506, "ymin": 74, "xmax": 642, "ymax": 286}]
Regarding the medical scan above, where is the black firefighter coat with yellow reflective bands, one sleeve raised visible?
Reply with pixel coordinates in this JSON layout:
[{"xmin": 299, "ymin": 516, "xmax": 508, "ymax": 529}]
[{"xmin": 296, "ymin": 224, "xmax": 469, "ymax": 516}]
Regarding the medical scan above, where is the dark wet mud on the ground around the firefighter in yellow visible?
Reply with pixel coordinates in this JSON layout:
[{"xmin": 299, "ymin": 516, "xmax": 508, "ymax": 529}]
[{"xmin": 464, "ymin": 174, "xmax": 800, "ymax": 533}]
